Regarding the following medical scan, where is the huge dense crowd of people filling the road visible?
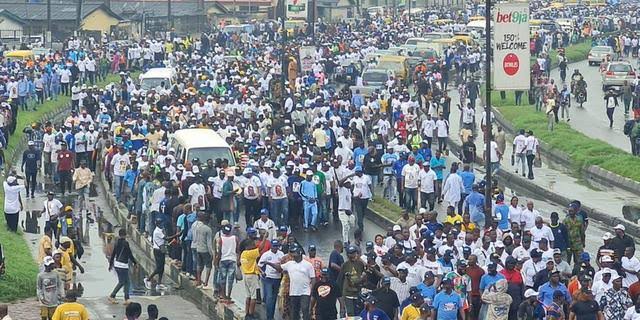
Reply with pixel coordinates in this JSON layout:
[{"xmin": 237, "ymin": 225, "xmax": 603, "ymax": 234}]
[{"xmin": 0, "ymin": 2, "xmax": 640, "ymax": 320}]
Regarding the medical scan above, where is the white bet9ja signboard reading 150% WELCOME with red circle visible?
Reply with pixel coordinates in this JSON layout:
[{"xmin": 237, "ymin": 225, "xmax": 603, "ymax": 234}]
[{"xmin": 491, "ymin": 2, "xmax": 531, "ymax": 90}]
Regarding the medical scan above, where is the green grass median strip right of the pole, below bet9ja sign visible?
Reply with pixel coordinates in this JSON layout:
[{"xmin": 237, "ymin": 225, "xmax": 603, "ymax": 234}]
[{"xmin": 495, "ymin": 104, "xmax": 640, "ymax": 181}]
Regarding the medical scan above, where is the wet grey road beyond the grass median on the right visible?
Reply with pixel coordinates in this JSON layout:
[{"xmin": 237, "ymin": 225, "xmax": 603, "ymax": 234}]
[{"xmin": 551, "ymin": 60, "xmax": 637, "ymax": 152}]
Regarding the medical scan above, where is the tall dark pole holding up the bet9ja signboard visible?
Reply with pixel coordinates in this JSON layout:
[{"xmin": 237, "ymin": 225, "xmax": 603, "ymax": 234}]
[{"xmin": 484, "ymin": 0, "xmax": 493, "ymax": 227}]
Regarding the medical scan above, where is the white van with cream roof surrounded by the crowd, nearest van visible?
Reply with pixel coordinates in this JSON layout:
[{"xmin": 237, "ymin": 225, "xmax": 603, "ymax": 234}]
[{"xmin": 169, "ymin": 129, "xmax": 236, "ymax": 167}]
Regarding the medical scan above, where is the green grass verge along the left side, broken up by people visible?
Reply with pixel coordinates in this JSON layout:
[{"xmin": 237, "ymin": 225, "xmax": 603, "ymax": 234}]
[{"xmin": 0, "ymin": 75, "xmax": 129, "ymax": 303}]
